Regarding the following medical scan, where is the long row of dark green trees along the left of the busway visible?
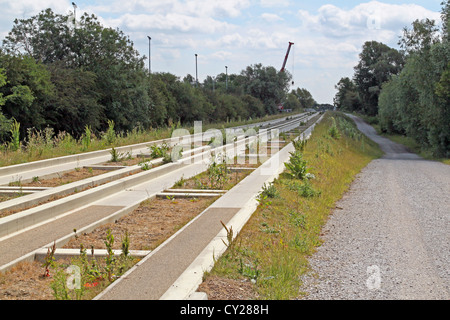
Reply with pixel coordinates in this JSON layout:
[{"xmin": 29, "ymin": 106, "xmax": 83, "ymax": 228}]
[{"xmin": 0, "ymin": 9, "xmax": 315, "ymax": 147}]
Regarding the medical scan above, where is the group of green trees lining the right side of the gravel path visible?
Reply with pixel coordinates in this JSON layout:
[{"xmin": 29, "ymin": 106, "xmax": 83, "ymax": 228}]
[{"xmin": 334, "ymin": 0, "xmax": 450, "ymax": 158}]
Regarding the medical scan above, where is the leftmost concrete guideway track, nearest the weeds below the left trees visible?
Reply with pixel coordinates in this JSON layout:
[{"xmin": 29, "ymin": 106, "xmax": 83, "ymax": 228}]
[{"xmin": 0, "ymin": 113, "xmax": 307, "ymax": 186}]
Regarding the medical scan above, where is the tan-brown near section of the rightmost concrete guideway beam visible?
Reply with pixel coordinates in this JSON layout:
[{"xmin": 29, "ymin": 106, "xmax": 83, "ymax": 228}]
[{"xmin": 95, "ymin": 208, "xmax": 238, "ymax": 300}]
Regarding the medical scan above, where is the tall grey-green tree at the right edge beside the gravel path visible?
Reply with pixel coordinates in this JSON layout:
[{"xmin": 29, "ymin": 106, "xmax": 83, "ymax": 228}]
[{"xmin": 379, "ymin": 2, "xmax": 450, "ymax": 157}]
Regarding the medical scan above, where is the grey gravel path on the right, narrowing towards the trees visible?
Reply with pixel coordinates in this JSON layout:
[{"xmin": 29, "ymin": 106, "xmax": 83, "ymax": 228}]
[{"xmin": 301, "ymin": 117, "xmax": 450, "ymax": 300}]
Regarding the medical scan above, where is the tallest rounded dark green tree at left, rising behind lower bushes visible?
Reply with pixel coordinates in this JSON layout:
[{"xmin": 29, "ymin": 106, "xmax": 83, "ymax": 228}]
[{"xmin": 3, "ymin": 9, "xmax": 150, "ymax": 130}]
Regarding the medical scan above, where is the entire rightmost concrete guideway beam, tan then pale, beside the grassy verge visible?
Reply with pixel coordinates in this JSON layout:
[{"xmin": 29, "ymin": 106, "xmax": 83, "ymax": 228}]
[{"xmin": 95, "ymin": 112, "xmax": 322, "ymax": 300}]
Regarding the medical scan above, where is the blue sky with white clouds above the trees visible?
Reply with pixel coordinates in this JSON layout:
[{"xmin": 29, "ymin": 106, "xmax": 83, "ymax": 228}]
[{"xmin": 0, "ymin": 0, "xmax": 442, "ymax": 104}]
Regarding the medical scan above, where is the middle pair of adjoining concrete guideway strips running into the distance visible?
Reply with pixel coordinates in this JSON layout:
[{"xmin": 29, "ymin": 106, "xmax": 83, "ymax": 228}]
[{"xmin": 0, "ymin": 112, "xmax": 318, "ymax": 271}]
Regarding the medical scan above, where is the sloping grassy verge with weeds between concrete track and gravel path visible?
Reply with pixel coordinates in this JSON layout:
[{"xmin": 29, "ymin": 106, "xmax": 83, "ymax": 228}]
[{"xmin": 199, "ymin": 112, "xmax": 382, "ymax": 300}]
